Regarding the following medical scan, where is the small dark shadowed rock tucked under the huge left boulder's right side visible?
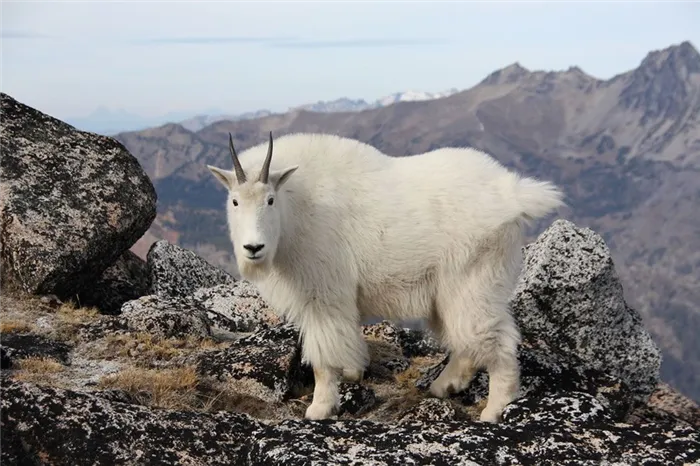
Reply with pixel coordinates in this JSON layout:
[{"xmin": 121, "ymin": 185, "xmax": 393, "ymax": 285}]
[{"xmin": 79, "ymin": 251, "xmax": 150, "ymax": 314}]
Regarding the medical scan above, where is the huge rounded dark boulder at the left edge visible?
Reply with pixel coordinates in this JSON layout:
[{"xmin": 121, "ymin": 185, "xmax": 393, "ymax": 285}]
[{"xmin": 0, "ymin": 93, "xmax": 156, "ymax": 299}]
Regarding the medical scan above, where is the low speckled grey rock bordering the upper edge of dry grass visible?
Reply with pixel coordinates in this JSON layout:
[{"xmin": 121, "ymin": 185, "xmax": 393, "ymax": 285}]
[{"xmin": 121, "ymin": 295, "xmax": 211, "ymax": 338}]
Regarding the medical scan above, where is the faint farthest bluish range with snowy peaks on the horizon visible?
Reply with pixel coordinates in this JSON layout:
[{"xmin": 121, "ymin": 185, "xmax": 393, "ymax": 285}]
[{"xmin": 65, "ymin": 89, "xmax": 458, "ymax": 135}]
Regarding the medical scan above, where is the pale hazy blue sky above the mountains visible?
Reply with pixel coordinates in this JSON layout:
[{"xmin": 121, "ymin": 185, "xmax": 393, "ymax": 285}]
[{"xmin": 0, "ymin": 0, "xmax": 700, "ymax": 118}]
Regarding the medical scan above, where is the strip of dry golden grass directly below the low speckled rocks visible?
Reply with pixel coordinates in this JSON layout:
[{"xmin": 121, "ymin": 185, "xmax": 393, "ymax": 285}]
[{"xmin": 90, "ymin": 333, "xmax": 230, "ymax": 367}]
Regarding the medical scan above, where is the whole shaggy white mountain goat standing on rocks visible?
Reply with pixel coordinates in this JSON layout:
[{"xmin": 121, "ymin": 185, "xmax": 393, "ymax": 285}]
[{"xmin": 207, "ymin": 133, "xmax": 564, "ymax": 422}]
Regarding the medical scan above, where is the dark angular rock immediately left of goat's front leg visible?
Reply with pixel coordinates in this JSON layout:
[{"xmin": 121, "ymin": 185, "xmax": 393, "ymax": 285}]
[{"xmin": 197, "ymin": 325, "xmax": 312, "ymax": 402}]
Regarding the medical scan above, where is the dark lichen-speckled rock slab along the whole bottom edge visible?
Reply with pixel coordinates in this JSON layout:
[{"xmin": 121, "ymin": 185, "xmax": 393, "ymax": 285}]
[{"xmin": 5, "ymin": 378, "xmax": 700, "ymax": 466}]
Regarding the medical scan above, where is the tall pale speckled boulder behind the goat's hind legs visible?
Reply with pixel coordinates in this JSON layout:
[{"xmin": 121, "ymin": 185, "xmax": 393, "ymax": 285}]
[{"xmin": 512, "ymin": 220, "xmax": 661, "ymax": 399}]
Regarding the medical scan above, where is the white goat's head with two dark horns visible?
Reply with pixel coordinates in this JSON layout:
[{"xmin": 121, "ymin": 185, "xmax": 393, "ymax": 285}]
[{"xmin": 207, "ymin": 132, "xmax": 298, "ymax": 273}]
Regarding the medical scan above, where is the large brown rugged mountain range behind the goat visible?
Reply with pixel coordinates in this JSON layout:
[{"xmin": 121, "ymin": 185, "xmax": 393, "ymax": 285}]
[{"xmin": 116, "ymin": 42, "xmax": 700, "ymax": 401}]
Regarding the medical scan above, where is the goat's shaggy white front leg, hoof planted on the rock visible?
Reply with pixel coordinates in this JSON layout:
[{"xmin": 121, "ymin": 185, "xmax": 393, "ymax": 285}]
[{"xmin": 302, "ymin": 307, "xmax": 369, "ymax": 419}]
